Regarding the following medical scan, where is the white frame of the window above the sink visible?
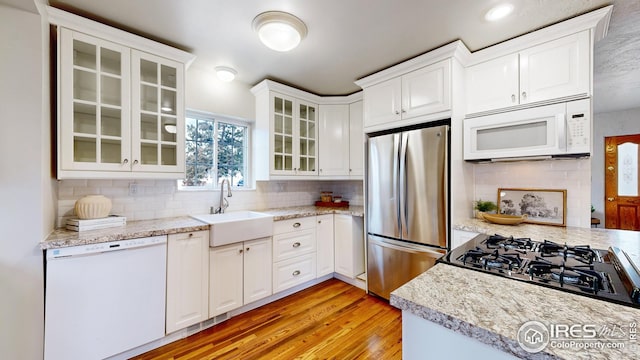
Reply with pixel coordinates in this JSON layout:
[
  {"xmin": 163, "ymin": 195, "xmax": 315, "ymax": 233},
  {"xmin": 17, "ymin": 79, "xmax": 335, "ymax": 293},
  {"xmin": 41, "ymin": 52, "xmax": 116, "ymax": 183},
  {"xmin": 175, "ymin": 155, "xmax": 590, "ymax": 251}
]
[{"xmin": 177, "ymin": 109, "xmax": 254, "ymax": 192}]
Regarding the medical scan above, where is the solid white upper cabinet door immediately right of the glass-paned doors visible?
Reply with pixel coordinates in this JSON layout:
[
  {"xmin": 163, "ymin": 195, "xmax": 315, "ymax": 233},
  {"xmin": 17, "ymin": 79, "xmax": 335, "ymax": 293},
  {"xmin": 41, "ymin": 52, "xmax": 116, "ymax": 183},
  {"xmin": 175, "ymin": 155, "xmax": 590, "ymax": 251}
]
[{"xmin": 318, "ymin": 105, "xmax": 349, "ymax": 176}]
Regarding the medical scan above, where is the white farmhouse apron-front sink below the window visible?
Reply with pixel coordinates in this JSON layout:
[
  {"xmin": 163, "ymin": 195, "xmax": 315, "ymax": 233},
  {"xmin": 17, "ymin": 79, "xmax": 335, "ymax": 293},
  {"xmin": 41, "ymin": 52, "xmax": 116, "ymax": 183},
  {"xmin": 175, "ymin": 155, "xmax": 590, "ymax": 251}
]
[{"xmin": 191, "ymin": 211, "xmax": 273, "ymax": 246}]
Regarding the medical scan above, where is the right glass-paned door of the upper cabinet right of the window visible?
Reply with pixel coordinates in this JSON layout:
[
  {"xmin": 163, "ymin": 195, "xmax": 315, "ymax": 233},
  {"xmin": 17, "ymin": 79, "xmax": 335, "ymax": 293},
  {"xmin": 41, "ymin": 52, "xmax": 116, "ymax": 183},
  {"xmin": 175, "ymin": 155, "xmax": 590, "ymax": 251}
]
[{"xmin": 294, "ymin": 101, "xmax": 318, "ymax": 175}]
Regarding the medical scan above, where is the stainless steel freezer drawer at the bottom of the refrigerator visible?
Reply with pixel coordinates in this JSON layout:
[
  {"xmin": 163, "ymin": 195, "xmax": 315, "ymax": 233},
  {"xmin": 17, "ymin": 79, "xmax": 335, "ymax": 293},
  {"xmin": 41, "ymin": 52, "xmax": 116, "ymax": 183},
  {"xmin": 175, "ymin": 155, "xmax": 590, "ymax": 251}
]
[{"xmin": 367, "ymin": 234, "xmax": 446, "ymax": 300}]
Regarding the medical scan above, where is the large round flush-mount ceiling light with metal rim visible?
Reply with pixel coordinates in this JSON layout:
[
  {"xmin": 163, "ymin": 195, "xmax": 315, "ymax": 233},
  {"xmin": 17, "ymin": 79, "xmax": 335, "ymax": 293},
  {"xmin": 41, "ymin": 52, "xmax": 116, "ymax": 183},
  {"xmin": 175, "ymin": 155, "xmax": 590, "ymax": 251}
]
[{"xmin": 253, "ymin": 11, "xmax": 307, "ymax": 51}]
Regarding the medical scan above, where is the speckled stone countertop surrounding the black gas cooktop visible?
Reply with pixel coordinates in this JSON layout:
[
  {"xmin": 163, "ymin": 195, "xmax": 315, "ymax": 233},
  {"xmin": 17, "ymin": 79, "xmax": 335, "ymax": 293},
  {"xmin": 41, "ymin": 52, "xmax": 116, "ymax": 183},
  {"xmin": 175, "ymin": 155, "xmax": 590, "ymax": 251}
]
[{"xmin": 390, "ymin": 219, "xmax": 640, "ymax": 359}]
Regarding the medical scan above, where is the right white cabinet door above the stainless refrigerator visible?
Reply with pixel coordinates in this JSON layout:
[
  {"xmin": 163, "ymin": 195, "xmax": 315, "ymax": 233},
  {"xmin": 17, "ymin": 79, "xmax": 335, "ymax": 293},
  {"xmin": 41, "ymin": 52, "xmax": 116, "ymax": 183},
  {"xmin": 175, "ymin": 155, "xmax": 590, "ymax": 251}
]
[{"xmin": 402, "ymin": 60, "xmax": 451, "ymax": 119}]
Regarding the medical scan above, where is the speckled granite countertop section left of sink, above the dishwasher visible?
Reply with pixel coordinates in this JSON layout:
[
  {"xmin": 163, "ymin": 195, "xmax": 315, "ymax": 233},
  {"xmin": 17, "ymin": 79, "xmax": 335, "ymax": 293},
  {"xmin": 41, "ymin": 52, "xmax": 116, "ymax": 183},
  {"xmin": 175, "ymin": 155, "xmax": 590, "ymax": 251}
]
[{"xmin": 40, "ymin": 216, "xmax": 209, "ymax": 249}]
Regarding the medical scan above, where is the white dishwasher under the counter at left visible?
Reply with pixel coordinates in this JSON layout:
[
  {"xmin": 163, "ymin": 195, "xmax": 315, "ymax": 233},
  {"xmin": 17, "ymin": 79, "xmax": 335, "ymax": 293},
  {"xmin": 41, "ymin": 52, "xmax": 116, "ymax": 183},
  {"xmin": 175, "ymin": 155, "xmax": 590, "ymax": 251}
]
[{"xmin": 44, "ymin": 236, "xmax": 167, "ymax": 360}]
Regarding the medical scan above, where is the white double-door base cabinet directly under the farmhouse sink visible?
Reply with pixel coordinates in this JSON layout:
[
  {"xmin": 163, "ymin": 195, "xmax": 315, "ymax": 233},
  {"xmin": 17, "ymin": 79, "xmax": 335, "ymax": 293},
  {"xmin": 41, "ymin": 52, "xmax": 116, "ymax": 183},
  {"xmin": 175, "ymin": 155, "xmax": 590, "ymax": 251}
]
[{"xmin": 209, "ymin": 238, "xmax": 272, "ymax": 318}]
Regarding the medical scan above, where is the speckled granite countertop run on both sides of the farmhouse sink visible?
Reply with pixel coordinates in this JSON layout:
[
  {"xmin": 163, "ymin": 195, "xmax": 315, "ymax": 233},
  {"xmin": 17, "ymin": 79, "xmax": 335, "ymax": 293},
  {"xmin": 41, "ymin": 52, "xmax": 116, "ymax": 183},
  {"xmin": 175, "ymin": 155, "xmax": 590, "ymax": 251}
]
[{"xmin": 40, "ymin": 206, "xmax": 364, "ymax": 250}]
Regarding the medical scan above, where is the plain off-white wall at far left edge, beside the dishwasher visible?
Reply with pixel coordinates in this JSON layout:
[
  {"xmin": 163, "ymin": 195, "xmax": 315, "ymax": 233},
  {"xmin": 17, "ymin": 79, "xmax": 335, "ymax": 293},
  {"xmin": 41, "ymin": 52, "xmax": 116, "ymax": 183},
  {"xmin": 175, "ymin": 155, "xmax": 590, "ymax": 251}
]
[{"xmin": 0, "ymin": 5, "xmax": 55, "ymax": 359}]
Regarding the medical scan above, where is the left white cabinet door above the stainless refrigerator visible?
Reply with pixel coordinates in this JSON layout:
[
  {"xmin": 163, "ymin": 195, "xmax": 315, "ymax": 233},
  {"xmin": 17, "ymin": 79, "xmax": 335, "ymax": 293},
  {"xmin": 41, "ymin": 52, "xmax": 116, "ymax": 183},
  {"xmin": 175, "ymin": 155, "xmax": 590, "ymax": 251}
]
[{"xmin": 364, "ymin": 77, "xmax": 402, "ymax": 128}]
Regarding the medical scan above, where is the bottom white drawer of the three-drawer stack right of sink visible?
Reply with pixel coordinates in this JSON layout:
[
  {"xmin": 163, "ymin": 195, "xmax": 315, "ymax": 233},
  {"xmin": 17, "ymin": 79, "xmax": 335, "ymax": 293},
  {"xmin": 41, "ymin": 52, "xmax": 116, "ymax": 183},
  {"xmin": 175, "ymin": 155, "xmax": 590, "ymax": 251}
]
[{"xmin": 273, "ymin": 254, "xmax": 316, "ymax": 294}]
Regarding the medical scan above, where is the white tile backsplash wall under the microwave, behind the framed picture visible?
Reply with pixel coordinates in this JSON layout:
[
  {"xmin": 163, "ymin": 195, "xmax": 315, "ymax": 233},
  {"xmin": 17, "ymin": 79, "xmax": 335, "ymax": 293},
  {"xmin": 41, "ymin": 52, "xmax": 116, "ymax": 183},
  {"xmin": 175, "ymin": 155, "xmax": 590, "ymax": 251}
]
[{"xmin": 469, "ymin": 159, "xmax": 591, "ymax": 227}]
